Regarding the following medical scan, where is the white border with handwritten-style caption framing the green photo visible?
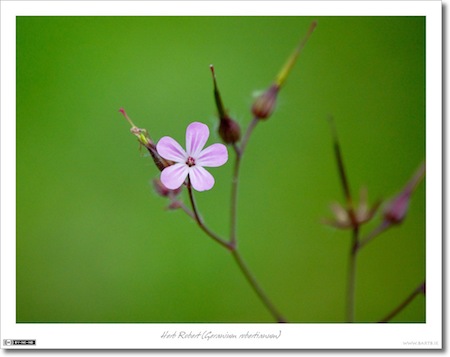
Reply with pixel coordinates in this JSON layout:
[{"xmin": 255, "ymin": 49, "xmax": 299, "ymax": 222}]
[{"xmin": 1, "ymin": 0, "xmax": 442, "ymax": 349}]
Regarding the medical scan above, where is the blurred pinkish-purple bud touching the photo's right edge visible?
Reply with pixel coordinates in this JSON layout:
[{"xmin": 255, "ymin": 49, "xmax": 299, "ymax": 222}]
[{"xmin": 384, "ymin": 163, "xmax": 425, "ymax": 224}]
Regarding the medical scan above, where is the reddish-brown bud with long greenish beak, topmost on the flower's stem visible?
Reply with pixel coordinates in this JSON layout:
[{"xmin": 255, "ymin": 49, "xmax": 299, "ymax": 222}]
[{"xmin": 252, "ymin": 21, "xmax": 317, "ymax": 119}]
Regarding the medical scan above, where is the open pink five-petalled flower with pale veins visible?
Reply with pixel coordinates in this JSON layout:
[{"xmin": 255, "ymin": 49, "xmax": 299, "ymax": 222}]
[{"xmin": 156, "ymin": 122, "xmax": 228, "ymax": 191}]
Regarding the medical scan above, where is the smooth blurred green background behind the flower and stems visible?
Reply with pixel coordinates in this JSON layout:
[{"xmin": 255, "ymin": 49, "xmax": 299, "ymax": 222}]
[{"xmin": 16, "ymin": 17, "xmax": 425, "ymax": 322}]
